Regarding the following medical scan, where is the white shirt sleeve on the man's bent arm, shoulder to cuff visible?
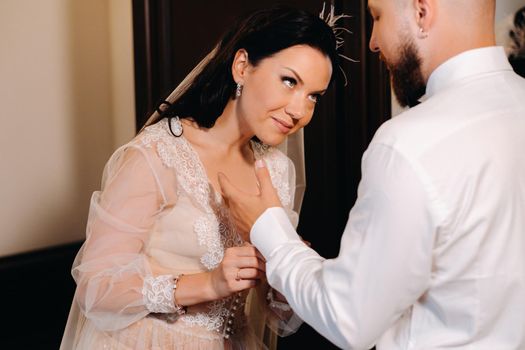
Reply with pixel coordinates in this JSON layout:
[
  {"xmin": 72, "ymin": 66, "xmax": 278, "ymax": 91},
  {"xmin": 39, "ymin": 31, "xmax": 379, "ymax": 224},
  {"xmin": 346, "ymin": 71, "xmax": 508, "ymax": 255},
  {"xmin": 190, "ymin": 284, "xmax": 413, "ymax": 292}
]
[{"xmin": 251, "ymin": 144, "xmax": 435, "ymax": 349}]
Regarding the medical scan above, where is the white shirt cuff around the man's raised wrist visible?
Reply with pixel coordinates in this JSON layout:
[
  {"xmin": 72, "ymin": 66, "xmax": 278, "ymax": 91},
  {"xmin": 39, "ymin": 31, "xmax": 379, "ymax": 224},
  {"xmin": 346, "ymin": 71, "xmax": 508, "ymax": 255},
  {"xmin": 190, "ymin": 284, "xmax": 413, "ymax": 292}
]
[{"xmin": 250, "ymin": 207, "xmax": 301, "ymax": 259}]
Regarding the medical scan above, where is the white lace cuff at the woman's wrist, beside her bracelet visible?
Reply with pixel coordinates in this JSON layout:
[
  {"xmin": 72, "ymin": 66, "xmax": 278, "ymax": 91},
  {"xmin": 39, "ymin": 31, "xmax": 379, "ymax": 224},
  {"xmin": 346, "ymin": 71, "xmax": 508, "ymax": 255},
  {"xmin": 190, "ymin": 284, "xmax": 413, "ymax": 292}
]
[{"xmin": 142, "ymin": 275, "xmax": 175, "ymax": 313}]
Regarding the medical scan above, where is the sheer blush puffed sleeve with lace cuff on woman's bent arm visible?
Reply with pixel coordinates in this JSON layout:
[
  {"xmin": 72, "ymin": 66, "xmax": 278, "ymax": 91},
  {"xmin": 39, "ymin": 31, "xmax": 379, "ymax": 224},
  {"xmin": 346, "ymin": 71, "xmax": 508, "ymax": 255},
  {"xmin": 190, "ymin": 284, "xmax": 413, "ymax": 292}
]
[{"xmin": 72, "ymin": 146, "xmax": 179, "ymax": 330}]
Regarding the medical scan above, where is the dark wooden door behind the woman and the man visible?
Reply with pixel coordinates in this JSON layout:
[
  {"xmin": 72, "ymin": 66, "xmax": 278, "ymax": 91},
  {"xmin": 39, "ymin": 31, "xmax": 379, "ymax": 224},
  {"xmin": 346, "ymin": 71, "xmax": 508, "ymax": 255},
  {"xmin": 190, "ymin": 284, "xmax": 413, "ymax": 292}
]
[{"xmin": 133, "ymin": 0, "xmax": 391, "ymax": 349}]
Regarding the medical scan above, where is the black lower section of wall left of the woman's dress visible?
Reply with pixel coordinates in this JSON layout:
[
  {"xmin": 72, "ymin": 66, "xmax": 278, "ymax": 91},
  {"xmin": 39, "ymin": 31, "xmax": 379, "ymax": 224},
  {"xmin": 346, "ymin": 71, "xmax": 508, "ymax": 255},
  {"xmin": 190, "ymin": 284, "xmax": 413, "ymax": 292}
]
[{"xmin": 0, "ymin": 243, "xmax": 80, "ymax": 350}]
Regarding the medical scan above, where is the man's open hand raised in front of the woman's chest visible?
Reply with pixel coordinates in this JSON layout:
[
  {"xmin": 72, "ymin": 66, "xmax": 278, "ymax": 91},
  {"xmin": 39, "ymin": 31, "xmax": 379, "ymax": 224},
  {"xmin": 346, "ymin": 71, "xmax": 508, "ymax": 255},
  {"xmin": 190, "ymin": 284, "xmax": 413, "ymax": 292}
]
[{"xmin": 219, "ymin": 160, "xmax": 282, "ymax": 242}]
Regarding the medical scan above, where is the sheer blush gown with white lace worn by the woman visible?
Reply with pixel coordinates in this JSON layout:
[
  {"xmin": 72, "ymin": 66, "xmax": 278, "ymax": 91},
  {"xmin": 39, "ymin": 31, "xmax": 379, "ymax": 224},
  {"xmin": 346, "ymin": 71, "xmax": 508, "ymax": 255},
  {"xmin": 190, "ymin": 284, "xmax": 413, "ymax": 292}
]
[{"xmin": 61, "ymin": 119, "xmax": 301, "ymax": 350}]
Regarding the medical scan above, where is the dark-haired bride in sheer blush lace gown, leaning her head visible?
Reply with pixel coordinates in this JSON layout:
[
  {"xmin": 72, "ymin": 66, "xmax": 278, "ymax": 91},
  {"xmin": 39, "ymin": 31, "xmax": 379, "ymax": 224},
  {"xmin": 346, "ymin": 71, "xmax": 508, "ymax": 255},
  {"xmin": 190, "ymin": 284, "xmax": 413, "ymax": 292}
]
[{"xmin": 61, "ymin": 7, "xmax": 338, "ymax": 350}]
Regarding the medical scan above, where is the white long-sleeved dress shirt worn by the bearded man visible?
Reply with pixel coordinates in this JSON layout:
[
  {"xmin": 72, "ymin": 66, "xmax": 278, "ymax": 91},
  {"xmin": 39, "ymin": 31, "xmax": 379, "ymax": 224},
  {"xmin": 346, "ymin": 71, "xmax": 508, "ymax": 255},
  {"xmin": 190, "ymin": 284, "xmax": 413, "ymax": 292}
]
[{"xmin": 251, "ymin": 47, "xmax": 525, "ymax": 350}]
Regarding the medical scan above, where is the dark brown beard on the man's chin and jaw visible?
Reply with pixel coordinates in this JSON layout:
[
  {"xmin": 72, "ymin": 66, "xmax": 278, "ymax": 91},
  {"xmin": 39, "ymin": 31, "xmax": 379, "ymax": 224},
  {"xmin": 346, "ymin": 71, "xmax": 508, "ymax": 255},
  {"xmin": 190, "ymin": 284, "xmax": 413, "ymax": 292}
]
[{"xmin": 387, "ymin": 39, "xmax": 426, "ymax": 107}]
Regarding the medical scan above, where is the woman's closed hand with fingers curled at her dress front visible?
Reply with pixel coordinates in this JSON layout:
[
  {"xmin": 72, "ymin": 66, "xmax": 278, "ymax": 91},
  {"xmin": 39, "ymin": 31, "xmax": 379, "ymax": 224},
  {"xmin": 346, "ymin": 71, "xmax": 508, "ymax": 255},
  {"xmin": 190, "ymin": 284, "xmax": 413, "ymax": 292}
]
[{"xmin": 210, "ymin": 243, "xmax": 266, "ymax": 299}]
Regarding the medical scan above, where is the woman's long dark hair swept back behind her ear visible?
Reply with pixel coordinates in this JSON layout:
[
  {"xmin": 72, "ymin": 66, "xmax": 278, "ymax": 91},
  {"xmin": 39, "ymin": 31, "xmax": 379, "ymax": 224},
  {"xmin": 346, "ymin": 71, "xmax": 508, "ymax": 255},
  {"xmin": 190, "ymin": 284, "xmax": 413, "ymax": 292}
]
[{"xmin": 149, "ymin": 6, "xmax": 339, "ymax": 128}]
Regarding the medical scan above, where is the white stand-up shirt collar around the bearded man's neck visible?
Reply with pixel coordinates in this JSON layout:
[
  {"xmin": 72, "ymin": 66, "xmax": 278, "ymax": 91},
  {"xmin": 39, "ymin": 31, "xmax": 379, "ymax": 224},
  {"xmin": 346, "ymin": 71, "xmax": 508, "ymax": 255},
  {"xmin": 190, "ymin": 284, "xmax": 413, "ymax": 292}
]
[{"xmin": 421, "ymin": 46, "xmax": 512, "ymax": 100}]
